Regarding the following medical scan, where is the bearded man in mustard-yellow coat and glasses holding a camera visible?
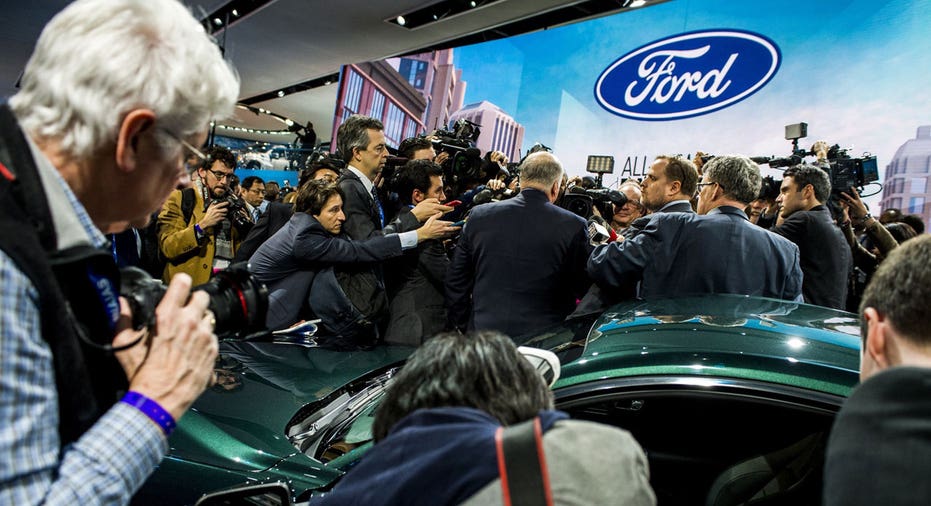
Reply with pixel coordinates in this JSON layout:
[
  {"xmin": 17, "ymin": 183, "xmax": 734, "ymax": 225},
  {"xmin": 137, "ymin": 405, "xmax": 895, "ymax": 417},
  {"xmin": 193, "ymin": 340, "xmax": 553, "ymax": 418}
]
[{"xmin": 158, "ymin": 146, "xmax": 253, "ymax": 285}]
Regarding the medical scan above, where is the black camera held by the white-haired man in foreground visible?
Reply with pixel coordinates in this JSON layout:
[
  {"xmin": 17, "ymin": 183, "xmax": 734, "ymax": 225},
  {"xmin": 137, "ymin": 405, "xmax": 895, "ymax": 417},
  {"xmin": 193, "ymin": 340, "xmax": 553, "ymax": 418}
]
[{"xmin": 120, "ymin": 263, "xmax": 268, "ymax": 337}]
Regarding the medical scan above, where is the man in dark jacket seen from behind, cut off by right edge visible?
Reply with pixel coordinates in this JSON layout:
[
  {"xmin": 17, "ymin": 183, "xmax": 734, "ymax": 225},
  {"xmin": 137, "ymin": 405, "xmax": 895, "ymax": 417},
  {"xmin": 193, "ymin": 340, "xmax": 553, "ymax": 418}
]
[{"xmin": 824, "ymin": 235, "xmax": 931, "ymax": 506}]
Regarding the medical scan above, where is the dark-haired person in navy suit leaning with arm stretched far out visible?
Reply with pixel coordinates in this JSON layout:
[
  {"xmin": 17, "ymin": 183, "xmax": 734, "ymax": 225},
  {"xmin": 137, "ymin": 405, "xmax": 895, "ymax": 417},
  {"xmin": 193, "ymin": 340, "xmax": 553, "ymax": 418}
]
[{"xmin": 249, "ymin": 180, "xmax": 458, "ymax": 342}]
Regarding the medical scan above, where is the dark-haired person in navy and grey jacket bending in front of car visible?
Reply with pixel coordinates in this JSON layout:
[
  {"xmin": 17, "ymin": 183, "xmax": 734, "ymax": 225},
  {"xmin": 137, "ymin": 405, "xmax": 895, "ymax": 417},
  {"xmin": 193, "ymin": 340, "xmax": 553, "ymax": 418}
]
[{"xmin": 312, "ymin": 332, "xmax": 656, "ymax": 506}]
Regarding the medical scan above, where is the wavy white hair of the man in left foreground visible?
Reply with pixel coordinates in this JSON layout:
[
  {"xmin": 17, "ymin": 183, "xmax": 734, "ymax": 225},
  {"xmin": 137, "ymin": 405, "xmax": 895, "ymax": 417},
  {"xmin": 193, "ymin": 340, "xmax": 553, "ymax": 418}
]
[{"xmin": 10, "ymin": 0, "xmax": 239, "ymax": 159}]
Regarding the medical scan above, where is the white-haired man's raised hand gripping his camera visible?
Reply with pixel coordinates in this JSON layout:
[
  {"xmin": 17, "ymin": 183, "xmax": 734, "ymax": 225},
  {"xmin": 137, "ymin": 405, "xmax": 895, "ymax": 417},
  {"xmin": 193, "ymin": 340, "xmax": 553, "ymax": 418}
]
[{"xmin": 113, "ymin": 274, "xmax": 217, "ymax": 420}]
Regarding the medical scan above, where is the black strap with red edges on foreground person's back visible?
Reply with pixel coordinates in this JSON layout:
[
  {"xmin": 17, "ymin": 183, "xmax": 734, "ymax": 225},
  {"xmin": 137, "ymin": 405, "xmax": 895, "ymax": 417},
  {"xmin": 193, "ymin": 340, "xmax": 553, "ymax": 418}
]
[{"xmin": 495, "ymin": 417, "xmax": 553, "ymax": 506}]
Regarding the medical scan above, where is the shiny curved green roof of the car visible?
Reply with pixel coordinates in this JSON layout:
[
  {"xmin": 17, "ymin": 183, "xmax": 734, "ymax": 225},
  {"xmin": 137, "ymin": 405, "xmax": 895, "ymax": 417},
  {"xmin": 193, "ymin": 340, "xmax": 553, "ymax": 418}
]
[{"xmin": 518, "ymin": 295, "xmax": 860, "ymax": 396}]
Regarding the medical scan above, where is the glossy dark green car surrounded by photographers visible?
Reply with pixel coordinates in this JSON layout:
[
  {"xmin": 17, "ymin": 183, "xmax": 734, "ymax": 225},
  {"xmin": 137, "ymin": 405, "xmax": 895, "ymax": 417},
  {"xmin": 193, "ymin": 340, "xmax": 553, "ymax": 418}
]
[{"xmin": 134, "ymin": 295, "xmax": 860, "ymax": 505}]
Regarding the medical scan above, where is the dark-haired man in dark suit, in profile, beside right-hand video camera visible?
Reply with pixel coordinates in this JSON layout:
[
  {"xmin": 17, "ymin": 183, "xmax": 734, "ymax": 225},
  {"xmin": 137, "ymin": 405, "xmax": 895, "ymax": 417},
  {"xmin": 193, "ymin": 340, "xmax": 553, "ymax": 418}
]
[{"xmin": 773, "ymin": 165, "xmax": 853, "ymax": 309}]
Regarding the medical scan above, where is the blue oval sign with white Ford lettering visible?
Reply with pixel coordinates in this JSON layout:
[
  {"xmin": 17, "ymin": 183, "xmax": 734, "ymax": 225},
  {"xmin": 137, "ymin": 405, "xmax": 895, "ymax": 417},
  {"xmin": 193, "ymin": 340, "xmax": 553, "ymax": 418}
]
[{"xmin": 595, "ymin": 30, "xmax": 781, "ymax": 121}]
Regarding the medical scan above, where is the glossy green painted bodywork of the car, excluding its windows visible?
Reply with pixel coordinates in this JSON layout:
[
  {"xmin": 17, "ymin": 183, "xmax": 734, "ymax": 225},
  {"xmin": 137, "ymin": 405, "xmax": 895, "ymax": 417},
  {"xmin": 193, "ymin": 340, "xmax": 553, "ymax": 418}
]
[{"xmin": 134, "ymin": 295, "xmax": 860, "ymax": 504}]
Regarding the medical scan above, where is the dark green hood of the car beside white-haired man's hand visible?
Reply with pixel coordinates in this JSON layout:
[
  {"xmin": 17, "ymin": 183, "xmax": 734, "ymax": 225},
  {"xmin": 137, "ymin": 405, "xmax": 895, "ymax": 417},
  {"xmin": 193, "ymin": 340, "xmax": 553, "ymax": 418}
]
[{"xmin": 169, "ymin": 342, "xmax": 413, "ymax": 481}]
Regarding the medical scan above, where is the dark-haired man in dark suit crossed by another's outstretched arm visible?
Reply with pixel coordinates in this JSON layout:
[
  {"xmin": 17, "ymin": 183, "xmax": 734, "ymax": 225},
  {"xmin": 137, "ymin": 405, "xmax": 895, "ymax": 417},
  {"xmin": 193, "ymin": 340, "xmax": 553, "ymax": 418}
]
[{"xmin": 385, "ymin": 159, "xmax": 449, "ymax": 346}]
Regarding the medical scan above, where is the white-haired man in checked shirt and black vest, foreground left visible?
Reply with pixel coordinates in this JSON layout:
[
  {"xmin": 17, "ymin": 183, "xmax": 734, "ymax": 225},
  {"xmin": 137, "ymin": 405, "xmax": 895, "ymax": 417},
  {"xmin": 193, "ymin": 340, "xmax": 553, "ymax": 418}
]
[{"xmin": 0, "ymin": 0, "xmax": 239, "ymax": 505}]
